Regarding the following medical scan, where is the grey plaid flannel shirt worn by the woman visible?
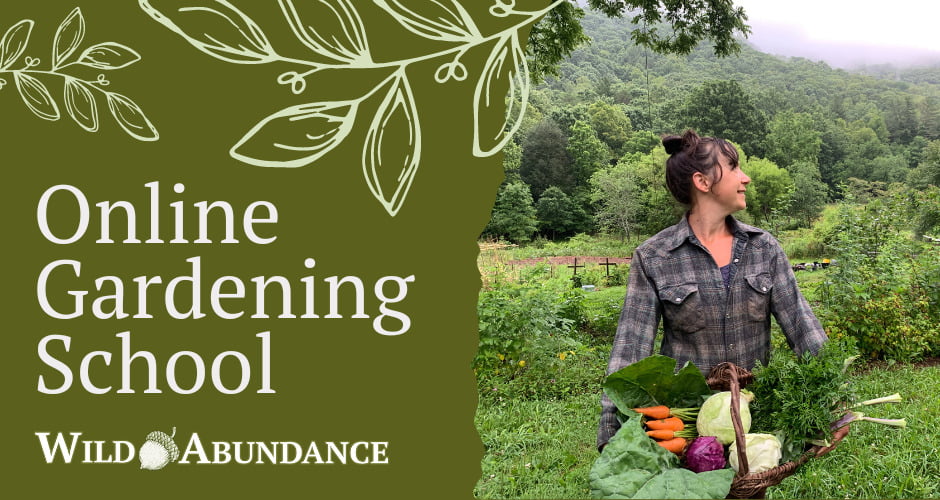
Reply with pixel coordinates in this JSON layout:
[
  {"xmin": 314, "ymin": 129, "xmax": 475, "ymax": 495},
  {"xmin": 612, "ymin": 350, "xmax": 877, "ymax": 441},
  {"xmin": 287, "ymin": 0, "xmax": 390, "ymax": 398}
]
[{"xmin": 597, "ymin": 216, "xmax": 826, "ymax": 448}]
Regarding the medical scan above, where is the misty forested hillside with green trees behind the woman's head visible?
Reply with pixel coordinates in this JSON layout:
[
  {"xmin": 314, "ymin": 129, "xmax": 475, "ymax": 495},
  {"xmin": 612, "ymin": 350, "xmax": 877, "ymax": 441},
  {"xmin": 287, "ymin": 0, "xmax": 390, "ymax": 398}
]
[{"xmin": 484, "ymin": 11, "xmax": 940, "ymax": 242}]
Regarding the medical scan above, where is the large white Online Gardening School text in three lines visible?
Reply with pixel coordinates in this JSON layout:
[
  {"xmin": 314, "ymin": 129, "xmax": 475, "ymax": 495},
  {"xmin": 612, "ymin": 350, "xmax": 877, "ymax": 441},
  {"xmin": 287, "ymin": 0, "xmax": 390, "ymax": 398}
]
[{"xmin": 36, "ymin": 181, "xmax": 415, "ymax": 394}]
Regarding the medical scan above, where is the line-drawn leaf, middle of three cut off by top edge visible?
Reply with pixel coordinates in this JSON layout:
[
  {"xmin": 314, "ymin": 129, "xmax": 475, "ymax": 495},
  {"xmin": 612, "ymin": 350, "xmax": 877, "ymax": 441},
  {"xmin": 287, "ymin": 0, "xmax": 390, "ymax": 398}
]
[{"xmin": 279, "ymin": 0, "xmax": 372, "ymax": 64}]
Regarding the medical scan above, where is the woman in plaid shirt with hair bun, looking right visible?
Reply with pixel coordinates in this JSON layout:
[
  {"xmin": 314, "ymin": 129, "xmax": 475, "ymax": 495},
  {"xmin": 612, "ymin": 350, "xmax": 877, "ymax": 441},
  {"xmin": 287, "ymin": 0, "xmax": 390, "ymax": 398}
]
[{"xmin": 597, "ymin": 130, "xmax": 826, "ymax": 449}]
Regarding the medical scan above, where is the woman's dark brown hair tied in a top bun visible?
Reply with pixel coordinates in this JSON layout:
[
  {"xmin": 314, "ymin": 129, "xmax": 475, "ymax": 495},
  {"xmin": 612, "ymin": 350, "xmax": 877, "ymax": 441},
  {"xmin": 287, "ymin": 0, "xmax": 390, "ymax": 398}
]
[{"xmin": 663, "ymin": 129, "xmax": 738, "ymax": 205}]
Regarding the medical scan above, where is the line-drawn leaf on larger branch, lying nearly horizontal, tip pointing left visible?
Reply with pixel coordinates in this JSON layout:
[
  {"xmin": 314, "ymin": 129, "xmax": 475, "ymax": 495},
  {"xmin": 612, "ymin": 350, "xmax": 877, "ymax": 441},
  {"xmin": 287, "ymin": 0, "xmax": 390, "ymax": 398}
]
[{"xmin": 229, "ymin": 101, "xmax": 359, "ymax": 168}]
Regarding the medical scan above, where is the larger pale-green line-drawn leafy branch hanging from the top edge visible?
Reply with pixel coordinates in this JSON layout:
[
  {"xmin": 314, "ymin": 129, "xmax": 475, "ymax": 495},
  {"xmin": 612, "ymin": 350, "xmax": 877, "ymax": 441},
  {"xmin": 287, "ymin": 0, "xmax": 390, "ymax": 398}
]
[{"xmin": 139, "ymin": 0, "xmax": 566, "ymax": 216}]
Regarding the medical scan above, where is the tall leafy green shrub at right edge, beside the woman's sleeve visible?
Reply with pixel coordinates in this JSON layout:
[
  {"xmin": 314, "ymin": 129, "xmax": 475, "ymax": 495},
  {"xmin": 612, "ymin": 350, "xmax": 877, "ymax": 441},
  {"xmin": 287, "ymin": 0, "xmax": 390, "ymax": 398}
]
[{"xmin": 821, "ymin": 192, "xmax": 940, "ymax": 361}]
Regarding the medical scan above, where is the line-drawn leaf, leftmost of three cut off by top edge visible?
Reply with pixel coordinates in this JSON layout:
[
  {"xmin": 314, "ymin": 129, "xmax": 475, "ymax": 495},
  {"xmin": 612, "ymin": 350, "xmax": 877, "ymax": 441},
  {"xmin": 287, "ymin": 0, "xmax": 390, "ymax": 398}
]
[{"xmin": 139, "ymin": 0, "xmax": 277, "ymax": 64}]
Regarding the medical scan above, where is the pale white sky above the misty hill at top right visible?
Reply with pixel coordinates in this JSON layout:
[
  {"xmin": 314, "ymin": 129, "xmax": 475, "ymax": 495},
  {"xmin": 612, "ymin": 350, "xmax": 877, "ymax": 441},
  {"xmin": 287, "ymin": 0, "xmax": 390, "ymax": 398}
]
[{"xmin": 734, "ymin": 0, "xmax": 940, "ymax": 67}]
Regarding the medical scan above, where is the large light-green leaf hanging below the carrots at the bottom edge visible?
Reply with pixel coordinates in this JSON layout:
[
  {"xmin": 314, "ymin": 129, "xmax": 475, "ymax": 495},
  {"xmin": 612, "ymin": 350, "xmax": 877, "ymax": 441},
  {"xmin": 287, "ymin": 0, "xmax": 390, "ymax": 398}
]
[{"xmin": 590, "ymin": 417, "xmax": 734, "ymax": 498}]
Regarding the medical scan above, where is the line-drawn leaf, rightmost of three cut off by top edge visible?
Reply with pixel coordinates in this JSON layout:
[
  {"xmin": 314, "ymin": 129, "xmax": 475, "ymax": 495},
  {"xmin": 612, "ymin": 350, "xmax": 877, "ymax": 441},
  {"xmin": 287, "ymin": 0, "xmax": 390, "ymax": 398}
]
[{"xmin": 373, "ymin": 0, "xmax": 483, "ymax": 42}]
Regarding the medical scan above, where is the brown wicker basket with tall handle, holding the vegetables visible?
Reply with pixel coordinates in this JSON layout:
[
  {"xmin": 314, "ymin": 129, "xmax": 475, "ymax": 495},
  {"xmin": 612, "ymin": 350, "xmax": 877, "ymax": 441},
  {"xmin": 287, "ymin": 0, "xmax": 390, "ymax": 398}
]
[{"xmin": 706, "ymin": 363, "xmax": 848, "ymax": 498}]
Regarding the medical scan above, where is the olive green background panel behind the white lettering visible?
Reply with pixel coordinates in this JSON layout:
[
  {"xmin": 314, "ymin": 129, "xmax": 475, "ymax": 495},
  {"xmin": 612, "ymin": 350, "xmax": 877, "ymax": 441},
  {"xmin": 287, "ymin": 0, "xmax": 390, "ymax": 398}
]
[{"xmin": 0, "ymin": 0, "xmax": 544, "ymax": 498}]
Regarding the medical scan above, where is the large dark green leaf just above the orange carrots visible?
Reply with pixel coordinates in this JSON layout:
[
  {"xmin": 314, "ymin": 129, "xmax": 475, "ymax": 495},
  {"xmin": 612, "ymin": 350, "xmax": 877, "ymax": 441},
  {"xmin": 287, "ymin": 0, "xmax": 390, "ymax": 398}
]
[{"xmin": 604, "ymin": 355, "xmax": 713, "ymax": 411}]
